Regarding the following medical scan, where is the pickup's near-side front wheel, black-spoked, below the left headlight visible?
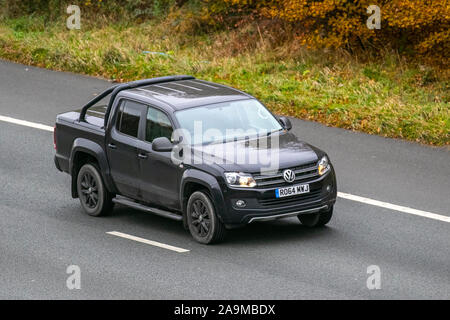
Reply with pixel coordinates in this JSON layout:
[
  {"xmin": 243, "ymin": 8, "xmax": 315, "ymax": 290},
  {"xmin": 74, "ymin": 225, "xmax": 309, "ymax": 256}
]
[{"xmin": 187, "ymin": 191, "xmax": 226, "ymax": 244}]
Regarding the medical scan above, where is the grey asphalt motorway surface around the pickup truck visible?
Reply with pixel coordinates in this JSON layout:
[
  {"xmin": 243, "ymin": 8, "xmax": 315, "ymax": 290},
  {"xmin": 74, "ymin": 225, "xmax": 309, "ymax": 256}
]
[{"xmin": 0, "ymin": 60, "xmax": 450, "ymax": 299}]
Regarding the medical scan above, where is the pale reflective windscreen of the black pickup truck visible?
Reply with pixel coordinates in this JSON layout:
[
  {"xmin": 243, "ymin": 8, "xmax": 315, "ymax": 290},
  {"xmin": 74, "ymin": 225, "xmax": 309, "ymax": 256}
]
[{"xmin": 175, "ymin": 99, "xmax": 282, "ymax": 144}]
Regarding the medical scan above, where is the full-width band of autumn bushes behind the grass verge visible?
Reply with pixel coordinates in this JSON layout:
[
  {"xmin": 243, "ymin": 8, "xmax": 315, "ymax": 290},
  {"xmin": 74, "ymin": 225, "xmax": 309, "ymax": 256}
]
[{"xmin": 0, "ymin": 0, "xmax": 450, "ymax": 65}]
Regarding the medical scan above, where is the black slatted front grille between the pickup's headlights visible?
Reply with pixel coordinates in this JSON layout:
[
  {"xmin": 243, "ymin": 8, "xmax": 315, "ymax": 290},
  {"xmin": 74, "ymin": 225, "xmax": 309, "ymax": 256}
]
[{"xmin": 253, "ymin": 162, "xmax": 319, "ymax": 187}]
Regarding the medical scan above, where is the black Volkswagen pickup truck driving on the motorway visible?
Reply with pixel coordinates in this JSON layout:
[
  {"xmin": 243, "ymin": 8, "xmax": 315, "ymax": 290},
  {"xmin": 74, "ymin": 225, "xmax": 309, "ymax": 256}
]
[{"xmin": 54, "ymin": 76, "xmax": 336, "ymax": 244}]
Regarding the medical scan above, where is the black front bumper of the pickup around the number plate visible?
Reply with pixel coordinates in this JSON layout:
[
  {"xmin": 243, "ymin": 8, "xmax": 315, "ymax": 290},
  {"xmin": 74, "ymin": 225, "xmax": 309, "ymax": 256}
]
[{"xmin": 221, "ymin": 168, "xmax": 337, "ymax": 228}]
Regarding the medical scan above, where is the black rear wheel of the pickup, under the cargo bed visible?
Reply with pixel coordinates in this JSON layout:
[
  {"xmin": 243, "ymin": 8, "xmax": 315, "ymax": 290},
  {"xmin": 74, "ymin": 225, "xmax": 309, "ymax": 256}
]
[{"xmin": 77, "ymin": 163, "xmax": 113, "ymax": 217}]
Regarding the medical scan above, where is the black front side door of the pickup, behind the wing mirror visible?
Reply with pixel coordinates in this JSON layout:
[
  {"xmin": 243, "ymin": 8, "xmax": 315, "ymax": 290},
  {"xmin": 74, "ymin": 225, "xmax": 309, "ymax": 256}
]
[{"xmin": 138, "ymin": 106, "xmax": 183, "ymax": 209}]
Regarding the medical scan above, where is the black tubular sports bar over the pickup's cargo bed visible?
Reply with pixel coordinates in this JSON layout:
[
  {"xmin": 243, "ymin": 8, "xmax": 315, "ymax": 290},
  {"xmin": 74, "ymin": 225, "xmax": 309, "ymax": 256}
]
[{"xmin": 78, "ymin": 75, "xmax": 195, "ymax": 127}]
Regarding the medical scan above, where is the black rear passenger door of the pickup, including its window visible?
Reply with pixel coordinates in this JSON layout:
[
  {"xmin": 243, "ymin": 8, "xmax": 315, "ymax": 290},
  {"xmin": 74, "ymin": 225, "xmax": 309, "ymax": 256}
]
[{"xmin": 106, "ymin": 99, "xmax": 147, "ymax": 199}]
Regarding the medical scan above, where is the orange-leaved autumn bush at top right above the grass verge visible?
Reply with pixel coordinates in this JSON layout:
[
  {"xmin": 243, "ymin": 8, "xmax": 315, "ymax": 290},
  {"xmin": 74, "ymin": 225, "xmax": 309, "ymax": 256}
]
[{"xmin": 217, "ymin": 0, "xmax": 450, "ymax": 59}]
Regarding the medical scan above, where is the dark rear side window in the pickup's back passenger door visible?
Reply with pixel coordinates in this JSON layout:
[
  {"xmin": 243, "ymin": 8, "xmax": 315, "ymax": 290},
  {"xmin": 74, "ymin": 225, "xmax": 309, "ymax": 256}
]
[{"xmin": 116, "ymin": 101, "xmax": 143, "ymax": 138}]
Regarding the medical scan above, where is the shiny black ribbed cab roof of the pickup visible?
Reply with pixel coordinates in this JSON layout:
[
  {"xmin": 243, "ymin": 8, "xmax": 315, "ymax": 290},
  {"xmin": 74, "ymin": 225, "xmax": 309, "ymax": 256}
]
[{"xmin": 125, "ymin": 79, "xmax": 253, "ymax": 110}]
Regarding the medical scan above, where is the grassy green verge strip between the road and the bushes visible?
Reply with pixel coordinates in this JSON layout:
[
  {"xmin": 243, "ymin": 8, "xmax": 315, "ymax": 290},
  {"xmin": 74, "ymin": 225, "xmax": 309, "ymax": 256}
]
[{"xmin": 0, "ymin": 17, "xmax": 450, "ymax": 146}]
